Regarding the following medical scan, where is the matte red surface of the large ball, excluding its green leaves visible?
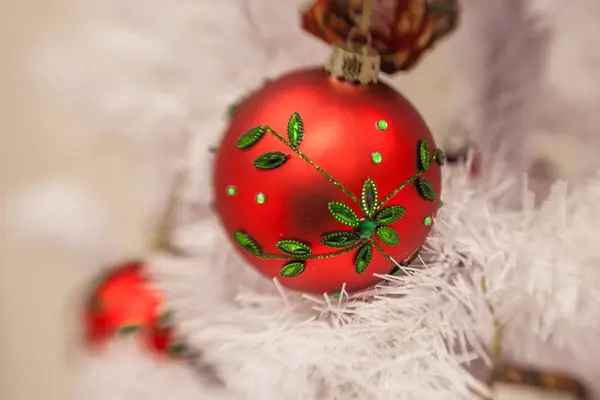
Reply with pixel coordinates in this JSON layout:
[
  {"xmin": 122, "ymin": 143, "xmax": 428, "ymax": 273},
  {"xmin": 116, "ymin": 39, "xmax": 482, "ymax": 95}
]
[{"xmin": 214, "ymin": 68, "xmax": 441, "ymax": 293}]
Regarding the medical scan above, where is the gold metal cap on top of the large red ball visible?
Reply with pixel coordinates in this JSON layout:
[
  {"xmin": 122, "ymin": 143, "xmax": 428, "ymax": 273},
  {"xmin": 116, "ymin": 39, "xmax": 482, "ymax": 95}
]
[{"xmin": 326, "ymin": 40, "xmax": 381, "ymax": 85}]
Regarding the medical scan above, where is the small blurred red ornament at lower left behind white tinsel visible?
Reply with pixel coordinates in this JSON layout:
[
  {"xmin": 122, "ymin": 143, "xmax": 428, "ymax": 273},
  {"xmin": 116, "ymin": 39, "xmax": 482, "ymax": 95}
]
[{"xmin": 84, "ymin": 261, "xmax": 183, "ymax": 354}]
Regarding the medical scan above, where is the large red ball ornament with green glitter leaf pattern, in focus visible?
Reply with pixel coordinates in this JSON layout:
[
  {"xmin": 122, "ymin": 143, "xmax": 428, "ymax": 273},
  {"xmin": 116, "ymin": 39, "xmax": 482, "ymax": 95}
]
[{"xmin": 214, "ymin": 68, "xmax": 444, "ymax": 293}]
